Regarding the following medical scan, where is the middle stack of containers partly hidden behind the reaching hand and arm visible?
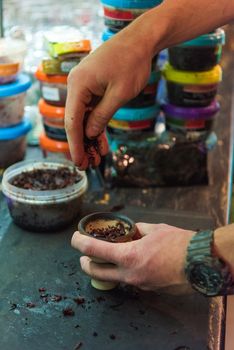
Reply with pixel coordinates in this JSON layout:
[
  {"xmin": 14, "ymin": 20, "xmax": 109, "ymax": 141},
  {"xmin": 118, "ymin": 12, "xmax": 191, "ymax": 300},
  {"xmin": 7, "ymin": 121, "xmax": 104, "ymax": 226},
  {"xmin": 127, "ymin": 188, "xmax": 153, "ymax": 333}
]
[{"xmin": 102, "ymin": 0, "xmax": 161, "ymax": 185}]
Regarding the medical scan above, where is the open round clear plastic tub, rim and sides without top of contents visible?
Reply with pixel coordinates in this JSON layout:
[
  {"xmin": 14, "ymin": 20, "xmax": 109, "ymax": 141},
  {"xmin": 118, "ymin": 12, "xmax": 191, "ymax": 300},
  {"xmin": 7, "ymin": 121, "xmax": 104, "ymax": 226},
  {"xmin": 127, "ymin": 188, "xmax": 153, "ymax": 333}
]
[{"xmin": 2, "ymin": 160, "xmax": 88, "ymax": 232}]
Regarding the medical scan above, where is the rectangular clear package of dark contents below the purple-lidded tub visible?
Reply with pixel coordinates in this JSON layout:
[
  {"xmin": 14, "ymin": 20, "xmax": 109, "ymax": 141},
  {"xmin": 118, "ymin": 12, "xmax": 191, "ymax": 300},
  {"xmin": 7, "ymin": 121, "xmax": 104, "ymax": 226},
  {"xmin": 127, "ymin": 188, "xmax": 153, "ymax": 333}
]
[{"xmin": 105, "ymin": 131, "xmax": 213, "ymax": 188}]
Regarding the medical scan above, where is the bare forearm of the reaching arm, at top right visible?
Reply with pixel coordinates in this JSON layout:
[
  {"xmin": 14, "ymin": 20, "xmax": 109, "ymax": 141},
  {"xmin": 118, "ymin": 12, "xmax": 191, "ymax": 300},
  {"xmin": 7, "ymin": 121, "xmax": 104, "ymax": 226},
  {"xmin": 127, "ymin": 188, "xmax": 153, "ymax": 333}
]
[{"xmin": 124, "ymin": 0, "xmax": 234, "ymax": 56}]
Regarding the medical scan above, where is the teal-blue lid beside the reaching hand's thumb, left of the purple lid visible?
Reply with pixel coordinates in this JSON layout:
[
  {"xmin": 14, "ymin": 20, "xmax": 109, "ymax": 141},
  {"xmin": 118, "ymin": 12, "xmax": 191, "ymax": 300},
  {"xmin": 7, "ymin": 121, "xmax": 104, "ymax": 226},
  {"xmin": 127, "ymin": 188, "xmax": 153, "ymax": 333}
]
[{"xmin": 113, "ymin": 105, "xmax": 159, "ymax": 122}]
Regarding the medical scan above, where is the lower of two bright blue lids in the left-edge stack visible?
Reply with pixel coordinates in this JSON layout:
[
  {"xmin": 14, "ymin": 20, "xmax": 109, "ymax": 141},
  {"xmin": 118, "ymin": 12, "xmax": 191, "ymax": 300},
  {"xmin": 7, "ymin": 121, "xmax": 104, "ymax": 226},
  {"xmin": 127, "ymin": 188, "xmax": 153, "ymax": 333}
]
[{"xmin": 0, "ymin": 118, "xmax": 32, "ymax": 140}]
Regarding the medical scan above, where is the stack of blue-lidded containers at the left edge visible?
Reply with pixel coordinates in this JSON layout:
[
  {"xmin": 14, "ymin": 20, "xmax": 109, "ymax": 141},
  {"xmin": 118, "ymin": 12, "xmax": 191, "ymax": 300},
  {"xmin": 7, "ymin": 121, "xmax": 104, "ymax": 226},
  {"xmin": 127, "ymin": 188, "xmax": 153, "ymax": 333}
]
[{"xmin": 0, "ymin": 38, "xmax": 31, "ymax": 172}]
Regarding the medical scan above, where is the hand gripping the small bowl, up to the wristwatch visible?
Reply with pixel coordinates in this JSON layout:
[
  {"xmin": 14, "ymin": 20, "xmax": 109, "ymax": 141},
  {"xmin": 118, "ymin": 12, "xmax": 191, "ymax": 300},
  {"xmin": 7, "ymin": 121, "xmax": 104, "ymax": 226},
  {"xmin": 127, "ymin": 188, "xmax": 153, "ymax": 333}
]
[{"xmin": 72, "ymin": 223, "xmax": 195, "ymax": 290}]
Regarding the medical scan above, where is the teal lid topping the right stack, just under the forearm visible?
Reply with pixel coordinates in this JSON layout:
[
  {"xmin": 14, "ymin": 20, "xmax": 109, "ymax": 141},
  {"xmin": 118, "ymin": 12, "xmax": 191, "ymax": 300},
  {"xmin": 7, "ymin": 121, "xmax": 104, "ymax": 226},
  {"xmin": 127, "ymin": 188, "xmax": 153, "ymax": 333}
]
[{"xmin": 177, "ymin": 28, "xmax": 225, "ymax": 47}]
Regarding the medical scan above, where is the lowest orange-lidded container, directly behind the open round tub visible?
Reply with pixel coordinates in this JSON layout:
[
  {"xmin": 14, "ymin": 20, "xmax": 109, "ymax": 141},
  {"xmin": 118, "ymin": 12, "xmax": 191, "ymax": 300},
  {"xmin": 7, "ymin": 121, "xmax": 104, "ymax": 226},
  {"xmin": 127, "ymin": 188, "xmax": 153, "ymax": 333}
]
[{"xmin": 39, "ymin": 133, "xmax": 71, "ymax": 160}]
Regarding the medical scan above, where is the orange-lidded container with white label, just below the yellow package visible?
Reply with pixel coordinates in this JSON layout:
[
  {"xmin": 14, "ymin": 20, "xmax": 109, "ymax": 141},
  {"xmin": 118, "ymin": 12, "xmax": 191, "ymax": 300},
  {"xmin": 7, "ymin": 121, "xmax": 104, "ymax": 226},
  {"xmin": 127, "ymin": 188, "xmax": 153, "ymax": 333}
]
[{"xmin": 35, "ymin": 66, "xmax": 67, "ymax": 107}]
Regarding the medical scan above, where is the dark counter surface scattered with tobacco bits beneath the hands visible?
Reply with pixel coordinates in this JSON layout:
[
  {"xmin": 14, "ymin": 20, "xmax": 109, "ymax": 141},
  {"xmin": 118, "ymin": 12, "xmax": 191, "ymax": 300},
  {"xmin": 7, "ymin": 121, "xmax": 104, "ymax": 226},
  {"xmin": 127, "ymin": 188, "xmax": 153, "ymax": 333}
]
[{"xmin": 0, "ymin": 26, "xmax": 234, "ymax": 350}]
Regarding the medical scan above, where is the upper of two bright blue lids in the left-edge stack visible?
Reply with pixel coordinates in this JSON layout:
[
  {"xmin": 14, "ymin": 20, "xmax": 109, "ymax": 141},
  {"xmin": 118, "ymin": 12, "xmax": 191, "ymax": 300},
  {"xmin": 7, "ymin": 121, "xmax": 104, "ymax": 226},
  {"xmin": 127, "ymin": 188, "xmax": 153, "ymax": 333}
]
[{"xmin": 0, "ymin": 73, "xmax": 31, "ymax": 98}]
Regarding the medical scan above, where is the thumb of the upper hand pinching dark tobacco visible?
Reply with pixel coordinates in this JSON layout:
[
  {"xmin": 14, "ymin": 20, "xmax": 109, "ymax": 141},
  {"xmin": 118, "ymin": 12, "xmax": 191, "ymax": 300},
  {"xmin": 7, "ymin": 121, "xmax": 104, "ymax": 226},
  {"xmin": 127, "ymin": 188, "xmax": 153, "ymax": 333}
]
[{"xmin": 86, "ymin": 92, "xmax": 124, "ymax": 138}]
